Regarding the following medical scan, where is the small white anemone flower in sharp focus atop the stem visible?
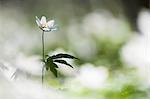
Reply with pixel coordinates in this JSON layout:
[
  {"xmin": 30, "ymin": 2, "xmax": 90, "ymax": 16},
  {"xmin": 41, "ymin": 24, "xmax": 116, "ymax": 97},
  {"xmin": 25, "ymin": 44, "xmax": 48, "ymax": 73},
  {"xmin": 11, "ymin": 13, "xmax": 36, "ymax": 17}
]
[{"xmin": 36, "ymin": 16, "xmax": 57, "ymax": 32}]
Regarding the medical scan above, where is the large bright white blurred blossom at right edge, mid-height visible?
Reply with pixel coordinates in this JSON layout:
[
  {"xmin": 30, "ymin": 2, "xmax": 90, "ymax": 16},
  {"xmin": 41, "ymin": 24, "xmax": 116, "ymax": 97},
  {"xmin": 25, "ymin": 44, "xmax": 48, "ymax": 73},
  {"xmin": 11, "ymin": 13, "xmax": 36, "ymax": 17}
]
[{"xmin": 122, "ymin": 35, "xmax": 150, "ymax": 67}]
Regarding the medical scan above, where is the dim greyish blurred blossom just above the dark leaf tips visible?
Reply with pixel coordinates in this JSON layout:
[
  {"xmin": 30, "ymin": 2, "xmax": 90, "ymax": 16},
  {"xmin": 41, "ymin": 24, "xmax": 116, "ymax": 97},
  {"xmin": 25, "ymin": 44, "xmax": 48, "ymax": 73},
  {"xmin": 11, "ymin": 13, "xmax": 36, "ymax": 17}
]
[{"xmin": 68, "ymin": 22, "xmax": 97, "ymax": 60}]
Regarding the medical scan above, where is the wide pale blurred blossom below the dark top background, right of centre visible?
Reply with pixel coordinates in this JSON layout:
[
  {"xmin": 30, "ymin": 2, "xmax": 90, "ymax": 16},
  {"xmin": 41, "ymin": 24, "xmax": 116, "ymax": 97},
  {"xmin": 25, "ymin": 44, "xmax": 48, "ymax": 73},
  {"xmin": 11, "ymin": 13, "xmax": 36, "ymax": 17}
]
[{"xmin": 81, "ymin": 10, "xmax": 130, "ymax": 42}]
